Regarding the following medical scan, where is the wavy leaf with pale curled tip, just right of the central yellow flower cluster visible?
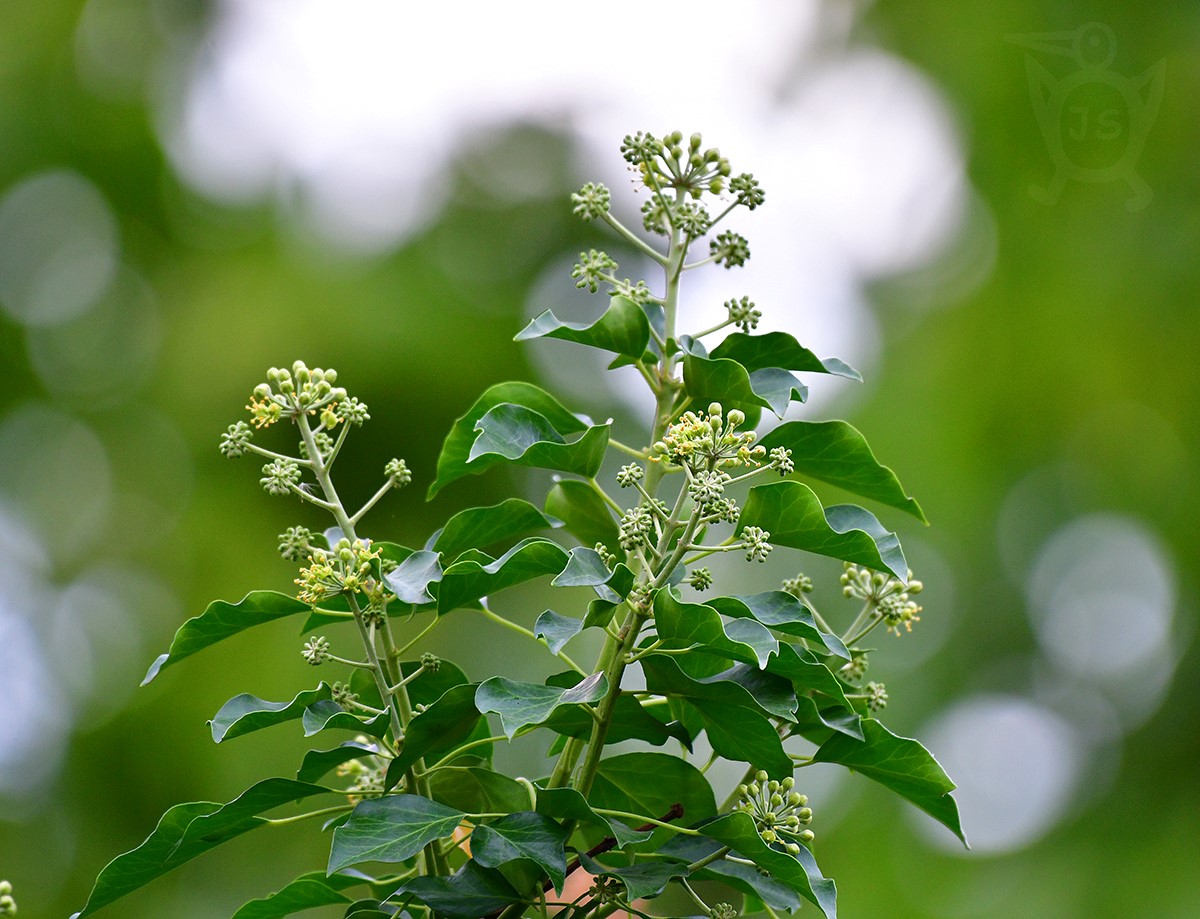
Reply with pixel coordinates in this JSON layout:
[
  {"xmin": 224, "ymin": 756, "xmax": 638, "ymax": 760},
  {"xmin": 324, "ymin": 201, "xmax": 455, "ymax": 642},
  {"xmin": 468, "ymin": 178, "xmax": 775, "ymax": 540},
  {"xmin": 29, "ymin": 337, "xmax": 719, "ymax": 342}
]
[{"xmin": 736, "ymin": 482, "xmax": 908, "ymax": 581}]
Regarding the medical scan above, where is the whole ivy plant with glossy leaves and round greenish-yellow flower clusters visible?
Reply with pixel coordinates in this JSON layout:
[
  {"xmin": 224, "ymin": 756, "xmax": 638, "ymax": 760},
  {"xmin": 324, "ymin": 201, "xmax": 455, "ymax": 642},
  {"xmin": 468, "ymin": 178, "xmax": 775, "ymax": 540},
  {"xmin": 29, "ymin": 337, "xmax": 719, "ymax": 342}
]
[{"xmin": 75, "ymin": 132, "xmax": 965, "ymax": 919}]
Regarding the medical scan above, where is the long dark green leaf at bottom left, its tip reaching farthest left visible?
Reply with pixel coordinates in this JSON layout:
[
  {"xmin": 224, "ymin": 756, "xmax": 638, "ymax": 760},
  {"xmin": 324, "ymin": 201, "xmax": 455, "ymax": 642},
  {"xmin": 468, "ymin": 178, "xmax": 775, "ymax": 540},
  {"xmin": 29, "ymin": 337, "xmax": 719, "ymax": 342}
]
[{"xmin": 72, "ymin": 779, "xmax": 331, "ymax": 919}]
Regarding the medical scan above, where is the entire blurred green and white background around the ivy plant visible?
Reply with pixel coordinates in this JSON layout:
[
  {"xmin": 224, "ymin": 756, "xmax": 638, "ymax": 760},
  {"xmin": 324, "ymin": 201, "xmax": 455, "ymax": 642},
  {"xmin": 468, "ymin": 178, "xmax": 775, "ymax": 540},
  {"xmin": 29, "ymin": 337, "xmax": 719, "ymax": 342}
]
[{"xmin": 0, "ymin": 0, "xmax": 1200, "ymax": 919}]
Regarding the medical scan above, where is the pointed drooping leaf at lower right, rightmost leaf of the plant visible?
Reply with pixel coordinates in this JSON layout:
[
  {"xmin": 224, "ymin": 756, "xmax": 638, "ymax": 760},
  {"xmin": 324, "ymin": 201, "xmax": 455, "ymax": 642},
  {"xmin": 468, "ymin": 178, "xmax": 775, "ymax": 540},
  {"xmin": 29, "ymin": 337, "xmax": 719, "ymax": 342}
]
[{"xmin": 812, "ymin": 719, "xmax": 967, "ymax": 845}]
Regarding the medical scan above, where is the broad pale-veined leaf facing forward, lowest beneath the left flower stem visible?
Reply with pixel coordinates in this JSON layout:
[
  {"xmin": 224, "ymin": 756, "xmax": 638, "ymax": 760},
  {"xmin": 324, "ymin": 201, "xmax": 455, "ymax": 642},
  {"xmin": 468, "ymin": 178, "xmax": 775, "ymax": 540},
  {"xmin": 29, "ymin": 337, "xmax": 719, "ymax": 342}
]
[{"xmin": 328, "ymin": 794, "xmax": 466, "ymax": 875}]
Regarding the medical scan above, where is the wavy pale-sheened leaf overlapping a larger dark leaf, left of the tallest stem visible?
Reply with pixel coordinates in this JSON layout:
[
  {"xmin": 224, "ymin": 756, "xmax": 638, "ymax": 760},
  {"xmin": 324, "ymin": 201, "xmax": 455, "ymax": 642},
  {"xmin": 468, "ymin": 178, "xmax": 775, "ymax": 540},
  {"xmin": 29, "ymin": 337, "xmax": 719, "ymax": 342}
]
[{"xmin": 467, "ymin": 402, "xmax": 608, "ymax": 479}]
